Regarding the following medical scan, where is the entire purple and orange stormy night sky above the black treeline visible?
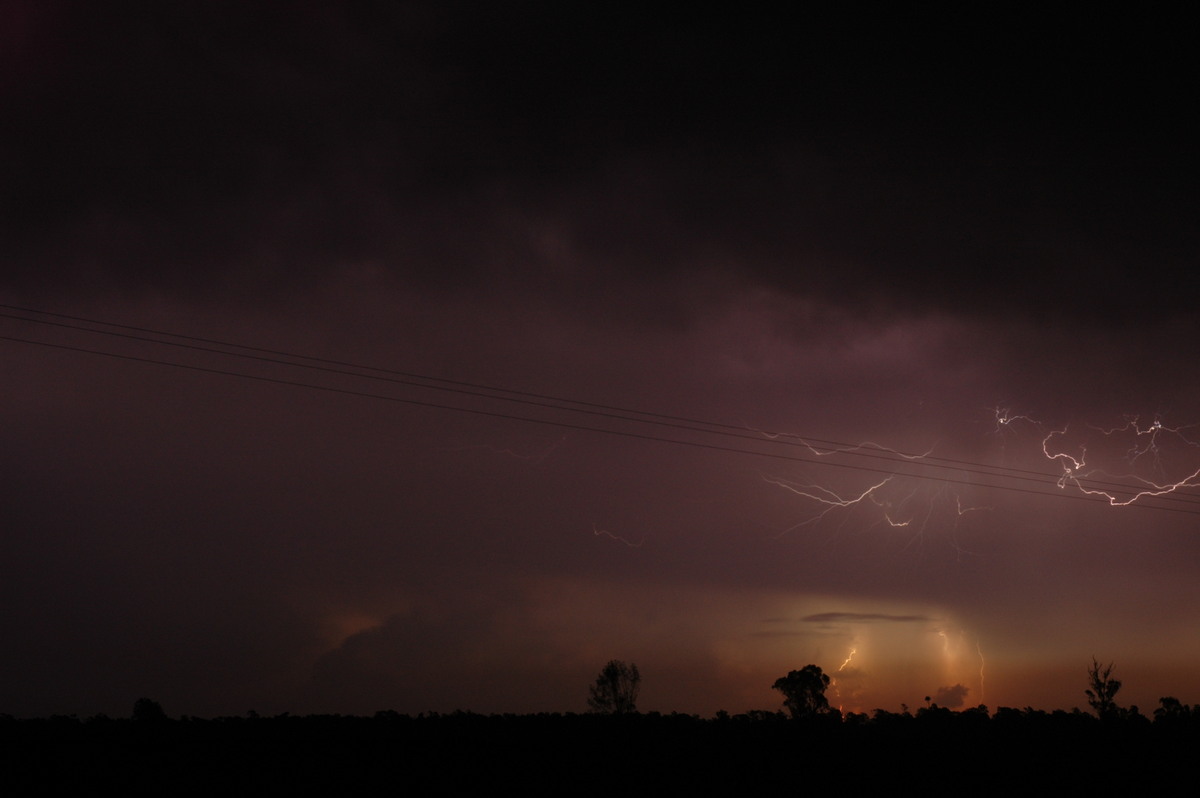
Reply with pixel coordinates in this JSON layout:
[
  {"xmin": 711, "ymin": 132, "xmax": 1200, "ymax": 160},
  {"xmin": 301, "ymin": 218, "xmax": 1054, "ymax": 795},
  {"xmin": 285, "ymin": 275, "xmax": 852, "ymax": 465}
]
[{"xmin": 0, "ymin": 0, "xmax": 1200, "ymax": 716}]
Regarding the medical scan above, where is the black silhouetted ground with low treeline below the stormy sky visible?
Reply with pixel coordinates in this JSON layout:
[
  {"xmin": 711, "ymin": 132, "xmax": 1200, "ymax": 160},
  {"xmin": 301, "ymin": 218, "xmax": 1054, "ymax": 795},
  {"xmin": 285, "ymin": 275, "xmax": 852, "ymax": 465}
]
[{"xmin": 0, "ymin": 702, "xmax": 1200, "ymax": 794}]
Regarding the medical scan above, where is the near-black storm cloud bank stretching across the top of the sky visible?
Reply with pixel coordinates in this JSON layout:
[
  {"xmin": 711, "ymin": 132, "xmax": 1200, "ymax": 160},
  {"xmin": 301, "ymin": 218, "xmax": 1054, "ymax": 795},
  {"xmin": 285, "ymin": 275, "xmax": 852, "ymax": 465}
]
[{"xmin": 4, "ymin": 2, "xmax": 1198, "ymax": 320}]
